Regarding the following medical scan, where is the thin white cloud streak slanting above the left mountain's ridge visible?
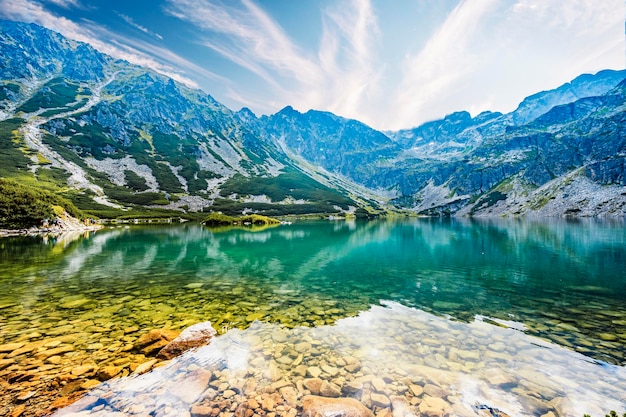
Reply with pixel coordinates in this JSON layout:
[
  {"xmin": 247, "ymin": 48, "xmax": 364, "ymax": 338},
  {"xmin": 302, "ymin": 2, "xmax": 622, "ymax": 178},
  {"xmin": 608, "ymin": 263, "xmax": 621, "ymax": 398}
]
[{"xmin": 0, "ymin": 0, "xmax": 218, "ymax": 88}]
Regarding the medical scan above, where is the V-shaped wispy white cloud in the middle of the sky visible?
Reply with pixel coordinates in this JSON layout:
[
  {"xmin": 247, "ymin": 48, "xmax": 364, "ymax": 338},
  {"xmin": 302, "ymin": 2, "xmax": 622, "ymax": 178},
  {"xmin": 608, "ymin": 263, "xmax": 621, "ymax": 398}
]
[{"xmin": 166, "ymin": 0, "xmax": 380, "ymax": 123}]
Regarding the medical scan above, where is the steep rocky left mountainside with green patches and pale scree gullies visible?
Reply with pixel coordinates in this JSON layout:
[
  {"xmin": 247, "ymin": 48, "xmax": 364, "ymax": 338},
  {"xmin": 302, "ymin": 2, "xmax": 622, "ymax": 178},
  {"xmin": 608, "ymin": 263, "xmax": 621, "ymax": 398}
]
[{"xmin": 0, "ymin": 22, "xmax": 368, "ymax": 218}]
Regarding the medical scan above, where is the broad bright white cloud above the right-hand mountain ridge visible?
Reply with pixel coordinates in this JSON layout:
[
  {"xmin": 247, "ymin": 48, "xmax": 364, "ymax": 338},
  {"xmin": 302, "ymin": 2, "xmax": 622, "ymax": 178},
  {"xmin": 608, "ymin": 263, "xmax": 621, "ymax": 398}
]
[{"xmin": 379, "ymin": 0, "xmax": 624, "ymax": 129}]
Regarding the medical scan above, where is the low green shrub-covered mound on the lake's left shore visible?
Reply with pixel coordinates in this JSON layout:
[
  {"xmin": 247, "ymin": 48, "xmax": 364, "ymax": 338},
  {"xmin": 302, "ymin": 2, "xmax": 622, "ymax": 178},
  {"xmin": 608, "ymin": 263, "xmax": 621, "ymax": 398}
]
[{"xmin": 0, "ymin": 179, "xmax": 85, "ymax": 229}]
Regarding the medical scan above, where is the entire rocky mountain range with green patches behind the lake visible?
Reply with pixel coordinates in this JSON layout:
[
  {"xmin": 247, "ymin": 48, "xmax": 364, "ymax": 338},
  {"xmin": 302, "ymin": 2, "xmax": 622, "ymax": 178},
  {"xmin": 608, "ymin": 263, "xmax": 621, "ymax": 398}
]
[{"xmin": 0, "ymin": 21, "xmax": 626, "ymax": 217}]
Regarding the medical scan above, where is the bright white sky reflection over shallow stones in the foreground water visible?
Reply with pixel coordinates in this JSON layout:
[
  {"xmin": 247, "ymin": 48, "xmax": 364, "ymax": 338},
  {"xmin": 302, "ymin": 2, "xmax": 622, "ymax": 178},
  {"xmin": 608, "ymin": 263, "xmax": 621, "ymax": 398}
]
[{"xmin": 55, "ymin": 302, "xmax": 626, "ymax": 417}]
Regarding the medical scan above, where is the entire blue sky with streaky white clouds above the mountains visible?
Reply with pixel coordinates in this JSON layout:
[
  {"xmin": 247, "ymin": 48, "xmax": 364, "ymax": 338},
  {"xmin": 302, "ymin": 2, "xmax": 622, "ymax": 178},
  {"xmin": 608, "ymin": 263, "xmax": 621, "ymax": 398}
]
[{"xmin": 0, "ymin": 0, "xmax": 626, "ymax": 129}]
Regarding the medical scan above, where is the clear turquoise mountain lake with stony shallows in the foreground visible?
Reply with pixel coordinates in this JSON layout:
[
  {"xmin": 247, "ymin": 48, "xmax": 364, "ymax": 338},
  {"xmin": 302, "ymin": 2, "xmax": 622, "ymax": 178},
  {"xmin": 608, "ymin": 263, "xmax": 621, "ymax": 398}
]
[{"xmin": 0, "ymin": 219, "xmax": 626, "ymax": 417}]
